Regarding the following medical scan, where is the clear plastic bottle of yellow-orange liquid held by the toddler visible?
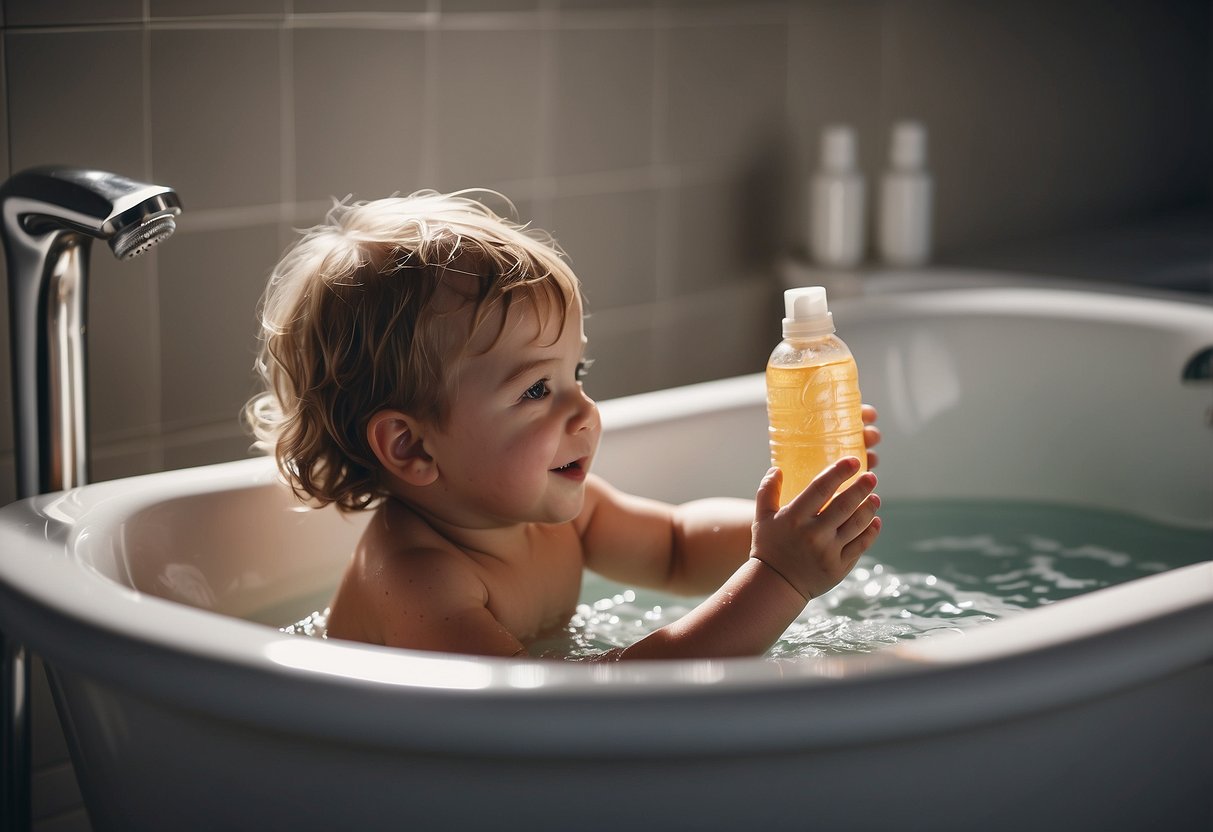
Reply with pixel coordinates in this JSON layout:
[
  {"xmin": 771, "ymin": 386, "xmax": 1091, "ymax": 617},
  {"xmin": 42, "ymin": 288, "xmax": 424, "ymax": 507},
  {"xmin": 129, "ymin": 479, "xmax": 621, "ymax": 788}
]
[{"xmin": 767, "ymin": 286, "xmax": 867, "ymax": 506}]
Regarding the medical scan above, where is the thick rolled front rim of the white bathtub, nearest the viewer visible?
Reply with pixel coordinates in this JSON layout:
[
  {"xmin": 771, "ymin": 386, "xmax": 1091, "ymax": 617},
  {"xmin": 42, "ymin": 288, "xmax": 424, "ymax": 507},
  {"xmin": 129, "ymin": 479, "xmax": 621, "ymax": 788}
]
[{"xmin": 0, "ymin": 494, "xmax": 1213, "ymax": 757}]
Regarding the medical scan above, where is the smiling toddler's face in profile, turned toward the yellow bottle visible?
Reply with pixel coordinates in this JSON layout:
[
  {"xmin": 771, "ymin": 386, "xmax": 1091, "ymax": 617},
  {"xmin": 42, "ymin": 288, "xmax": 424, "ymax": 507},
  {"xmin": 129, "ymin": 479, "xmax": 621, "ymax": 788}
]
[{"xmin": 427, "ymin": 293, "xmax": 602, "ymax": 525}]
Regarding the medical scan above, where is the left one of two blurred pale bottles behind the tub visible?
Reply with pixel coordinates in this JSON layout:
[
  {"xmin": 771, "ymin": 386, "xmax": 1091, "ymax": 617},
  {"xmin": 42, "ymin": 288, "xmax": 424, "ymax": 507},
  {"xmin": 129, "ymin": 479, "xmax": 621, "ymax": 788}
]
[{"xmin": 809, "ymin": 126, "xmax": 865, "ymax": 268}]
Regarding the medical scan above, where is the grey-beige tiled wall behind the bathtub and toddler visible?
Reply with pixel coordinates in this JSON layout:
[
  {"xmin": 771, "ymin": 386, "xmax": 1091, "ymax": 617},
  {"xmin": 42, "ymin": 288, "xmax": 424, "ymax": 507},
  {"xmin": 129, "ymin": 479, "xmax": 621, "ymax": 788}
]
[{"xmin": 0, "ymin": 0, "xmax": 1213, "ymax": 830}]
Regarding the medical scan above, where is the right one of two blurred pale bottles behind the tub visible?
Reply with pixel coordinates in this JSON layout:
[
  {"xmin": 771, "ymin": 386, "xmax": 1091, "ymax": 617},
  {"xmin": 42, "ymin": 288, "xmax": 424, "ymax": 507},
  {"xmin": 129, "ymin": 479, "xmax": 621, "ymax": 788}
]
[{"xmin": 877, "ymin": 121, "xmax": 933, "ymax": 267}]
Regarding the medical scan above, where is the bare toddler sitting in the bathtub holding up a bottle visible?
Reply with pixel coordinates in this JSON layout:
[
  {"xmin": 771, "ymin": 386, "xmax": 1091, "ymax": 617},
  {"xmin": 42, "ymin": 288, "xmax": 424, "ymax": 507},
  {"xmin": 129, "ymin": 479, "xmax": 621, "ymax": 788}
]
[{"xmin": 249, "ymin": 190, "xmax": 881, "ymax": 659}]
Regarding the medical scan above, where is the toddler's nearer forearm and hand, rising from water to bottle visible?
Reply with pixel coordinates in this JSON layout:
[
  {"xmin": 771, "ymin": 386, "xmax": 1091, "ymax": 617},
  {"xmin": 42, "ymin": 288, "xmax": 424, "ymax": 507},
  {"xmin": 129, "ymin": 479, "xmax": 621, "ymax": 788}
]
[{"xmin": 587, "ymin": 457, "xmax": 881, "ymax": 659}]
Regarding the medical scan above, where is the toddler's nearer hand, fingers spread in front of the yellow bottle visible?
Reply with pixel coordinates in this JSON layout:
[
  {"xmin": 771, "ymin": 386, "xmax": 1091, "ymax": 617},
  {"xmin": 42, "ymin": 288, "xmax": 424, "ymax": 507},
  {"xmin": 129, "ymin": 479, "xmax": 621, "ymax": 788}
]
[{"xmin": 750, "ymin": 463, "xmax": 881, "ymax": 602}]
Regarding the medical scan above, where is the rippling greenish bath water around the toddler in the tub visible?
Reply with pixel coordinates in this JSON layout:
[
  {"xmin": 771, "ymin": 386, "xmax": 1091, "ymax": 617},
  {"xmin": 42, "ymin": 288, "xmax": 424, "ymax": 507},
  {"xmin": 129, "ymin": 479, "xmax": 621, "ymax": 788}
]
[{"xmin": 278, "ymin": 500, "xmax": 1213, "ymax": 659}]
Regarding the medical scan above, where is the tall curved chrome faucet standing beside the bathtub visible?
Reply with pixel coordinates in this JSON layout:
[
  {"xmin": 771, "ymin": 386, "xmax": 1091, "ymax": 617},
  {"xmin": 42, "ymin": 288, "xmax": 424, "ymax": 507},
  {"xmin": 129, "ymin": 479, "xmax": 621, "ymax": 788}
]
[{"xmin": 0, "ymin": 167, "xmax": 181, "ymax": 830}]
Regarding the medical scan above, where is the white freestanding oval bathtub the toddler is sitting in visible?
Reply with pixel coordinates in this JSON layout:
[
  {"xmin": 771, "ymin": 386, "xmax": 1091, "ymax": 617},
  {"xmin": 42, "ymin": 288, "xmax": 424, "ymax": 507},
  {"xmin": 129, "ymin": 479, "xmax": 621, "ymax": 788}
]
[{"xmin": 0, "ymin": 283, "xmax": 1213, "ymax": 831}]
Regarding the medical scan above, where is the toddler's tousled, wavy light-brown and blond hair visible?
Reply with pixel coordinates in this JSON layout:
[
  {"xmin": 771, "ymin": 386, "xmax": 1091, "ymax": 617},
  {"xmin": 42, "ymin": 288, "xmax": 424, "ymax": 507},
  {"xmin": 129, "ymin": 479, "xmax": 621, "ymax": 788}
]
[{"xmin": 245, "ymin": 190, "xmax": 580, "ymax": 511}]
